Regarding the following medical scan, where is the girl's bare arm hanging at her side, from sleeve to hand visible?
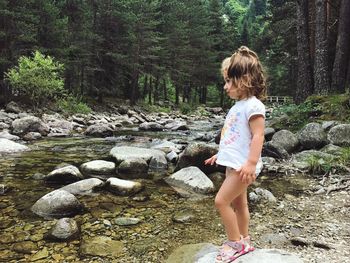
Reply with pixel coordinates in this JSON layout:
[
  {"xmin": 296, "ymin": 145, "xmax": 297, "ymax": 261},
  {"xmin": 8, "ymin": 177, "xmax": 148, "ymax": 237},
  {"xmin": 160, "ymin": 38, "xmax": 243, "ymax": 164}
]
[{"xmin": 239, "ymin": 115, "xmax": 265, "ymax": 184}]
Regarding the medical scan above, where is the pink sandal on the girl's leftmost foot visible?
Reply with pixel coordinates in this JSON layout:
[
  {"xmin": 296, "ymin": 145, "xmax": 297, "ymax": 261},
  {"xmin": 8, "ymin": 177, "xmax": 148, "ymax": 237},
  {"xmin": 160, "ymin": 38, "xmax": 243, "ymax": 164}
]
[{"xmin": 215, "ymin": 240, "xmax": 249, "ymax": 263}]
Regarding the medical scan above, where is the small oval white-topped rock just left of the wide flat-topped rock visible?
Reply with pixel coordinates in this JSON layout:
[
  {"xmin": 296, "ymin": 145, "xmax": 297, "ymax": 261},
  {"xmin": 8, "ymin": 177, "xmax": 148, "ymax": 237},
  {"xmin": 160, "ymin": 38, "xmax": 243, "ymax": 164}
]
[{"xmin": 80, "ymin": 160, "xmax": 115, "ymax": 179}]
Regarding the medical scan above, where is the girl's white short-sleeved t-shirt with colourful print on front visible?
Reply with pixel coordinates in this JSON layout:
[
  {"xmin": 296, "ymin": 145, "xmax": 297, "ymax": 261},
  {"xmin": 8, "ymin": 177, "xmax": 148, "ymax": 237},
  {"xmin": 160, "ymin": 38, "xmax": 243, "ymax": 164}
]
[{"xmin": 216, "ymin": 96, "xmax": 265, "ymax": 175}]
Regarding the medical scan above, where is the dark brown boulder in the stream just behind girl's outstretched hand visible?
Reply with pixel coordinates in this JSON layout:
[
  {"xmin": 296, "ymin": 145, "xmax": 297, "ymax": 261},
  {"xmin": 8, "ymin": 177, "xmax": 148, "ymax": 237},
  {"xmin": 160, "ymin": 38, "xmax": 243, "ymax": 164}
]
[{"xmin": 175, "ymin": 143, "xmax": 220, "ymax": 174}]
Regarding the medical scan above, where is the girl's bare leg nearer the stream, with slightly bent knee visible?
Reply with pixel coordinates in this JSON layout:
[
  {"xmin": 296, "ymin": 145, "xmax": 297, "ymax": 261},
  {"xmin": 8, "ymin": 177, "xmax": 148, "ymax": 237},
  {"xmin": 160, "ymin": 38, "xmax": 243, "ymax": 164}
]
[{"xmin": 215, "ymin": 169, "xmax": 248, "ymax": 241}]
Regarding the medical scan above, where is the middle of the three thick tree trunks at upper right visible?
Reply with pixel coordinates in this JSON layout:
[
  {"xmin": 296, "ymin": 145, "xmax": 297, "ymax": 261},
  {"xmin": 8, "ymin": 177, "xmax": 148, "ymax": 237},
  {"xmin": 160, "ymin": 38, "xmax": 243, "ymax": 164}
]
[{"xmin": 314, "ymin": 0, "xmax": 330, "ymax": 95}]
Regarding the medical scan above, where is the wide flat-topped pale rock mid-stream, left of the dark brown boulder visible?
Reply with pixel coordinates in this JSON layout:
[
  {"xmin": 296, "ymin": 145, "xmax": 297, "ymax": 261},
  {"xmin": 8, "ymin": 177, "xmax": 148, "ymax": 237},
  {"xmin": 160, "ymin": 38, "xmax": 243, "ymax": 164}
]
[{"xmin": 109, "ymin": 146, "xmax": 168, "ymax": 172}]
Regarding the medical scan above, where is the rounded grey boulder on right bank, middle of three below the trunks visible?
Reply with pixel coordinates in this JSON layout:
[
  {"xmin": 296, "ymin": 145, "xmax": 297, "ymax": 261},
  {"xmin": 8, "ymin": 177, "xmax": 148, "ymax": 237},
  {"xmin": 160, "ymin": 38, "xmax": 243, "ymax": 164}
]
[{"xmin": 298, "ymin": 122, "xmax": 328, "ymax": 150}]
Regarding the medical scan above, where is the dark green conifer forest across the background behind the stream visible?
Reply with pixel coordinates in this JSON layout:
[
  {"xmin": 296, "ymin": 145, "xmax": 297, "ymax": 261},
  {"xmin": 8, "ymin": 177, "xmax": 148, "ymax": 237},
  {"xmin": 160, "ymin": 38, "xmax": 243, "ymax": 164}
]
[{"xmin": 0, "ymin": 0, "xmax": 350, "ymax": 109}]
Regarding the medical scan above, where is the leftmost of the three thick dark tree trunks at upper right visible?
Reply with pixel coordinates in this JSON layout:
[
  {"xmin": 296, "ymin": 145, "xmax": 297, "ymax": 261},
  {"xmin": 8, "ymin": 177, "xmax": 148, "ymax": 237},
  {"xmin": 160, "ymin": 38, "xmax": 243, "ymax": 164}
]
[{"xmin": 294, "ymin": 0, "xmax": 312, "ymax": 103}]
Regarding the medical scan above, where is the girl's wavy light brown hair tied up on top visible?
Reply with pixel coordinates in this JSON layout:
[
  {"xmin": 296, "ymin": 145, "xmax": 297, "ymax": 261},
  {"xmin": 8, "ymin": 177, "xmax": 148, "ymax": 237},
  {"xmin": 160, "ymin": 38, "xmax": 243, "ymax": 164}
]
[{"xmin": 227, "ymin": 46, "xmax": 266, "ymax": 100}]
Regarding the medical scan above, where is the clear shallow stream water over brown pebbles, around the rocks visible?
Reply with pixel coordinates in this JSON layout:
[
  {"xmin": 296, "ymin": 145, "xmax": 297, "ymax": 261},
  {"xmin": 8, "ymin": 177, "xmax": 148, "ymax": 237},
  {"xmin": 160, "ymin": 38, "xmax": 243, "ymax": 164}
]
[{"xmin": 0, "ymin": 130, "xmax": 307, "ymax": 262}]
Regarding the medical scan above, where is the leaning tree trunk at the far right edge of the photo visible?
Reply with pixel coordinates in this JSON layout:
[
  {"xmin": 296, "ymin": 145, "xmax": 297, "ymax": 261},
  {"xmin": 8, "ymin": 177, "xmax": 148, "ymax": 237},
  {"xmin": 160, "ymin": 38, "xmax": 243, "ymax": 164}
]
[{"xmin": 331, "ymin": 0, "xmax": 350, "ymax": 93}]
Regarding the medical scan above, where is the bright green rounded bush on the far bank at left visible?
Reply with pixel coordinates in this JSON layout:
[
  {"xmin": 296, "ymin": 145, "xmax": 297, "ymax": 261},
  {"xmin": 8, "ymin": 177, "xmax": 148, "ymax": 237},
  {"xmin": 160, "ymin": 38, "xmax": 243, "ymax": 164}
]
[{"xmin": 5, "ymin": 51, "xmax": 64, "ymax": 106}]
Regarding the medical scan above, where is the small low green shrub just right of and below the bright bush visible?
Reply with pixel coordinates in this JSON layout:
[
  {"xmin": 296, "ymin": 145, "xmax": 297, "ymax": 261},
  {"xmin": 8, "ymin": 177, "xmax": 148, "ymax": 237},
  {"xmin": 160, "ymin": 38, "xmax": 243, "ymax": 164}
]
[{"xmin": 56, "ymin": 96, "xmax": 91, "ymax": 115}]
